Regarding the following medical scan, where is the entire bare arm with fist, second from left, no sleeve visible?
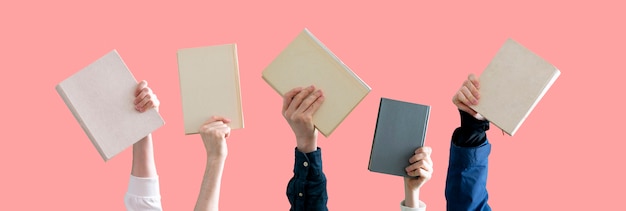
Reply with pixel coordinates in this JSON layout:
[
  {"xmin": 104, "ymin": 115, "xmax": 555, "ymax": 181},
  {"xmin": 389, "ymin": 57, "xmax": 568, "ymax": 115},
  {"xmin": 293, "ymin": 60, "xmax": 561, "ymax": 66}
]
[{"xmin": 194, "ymin": 116, "xmax": 230, "ymax": 211}]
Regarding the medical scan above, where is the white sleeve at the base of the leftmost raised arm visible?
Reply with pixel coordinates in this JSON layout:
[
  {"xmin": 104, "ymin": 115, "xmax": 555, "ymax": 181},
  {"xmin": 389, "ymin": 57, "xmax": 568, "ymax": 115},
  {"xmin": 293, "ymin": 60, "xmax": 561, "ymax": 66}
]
[{"xmin": 124, "ymin": 175, "xmax": 163, "ymax": 211}]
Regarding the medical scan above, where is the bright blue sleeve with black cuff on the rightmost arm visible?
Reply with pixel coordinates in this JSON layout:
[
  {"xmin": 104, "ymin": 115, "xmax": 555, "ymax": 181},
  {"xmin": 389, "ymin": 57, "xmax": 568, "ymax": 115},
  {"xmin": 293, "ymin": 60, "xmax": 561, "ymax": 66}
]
[{"xmin": 445, "ymin": 111, "xmax": 491, "ymax": 211}]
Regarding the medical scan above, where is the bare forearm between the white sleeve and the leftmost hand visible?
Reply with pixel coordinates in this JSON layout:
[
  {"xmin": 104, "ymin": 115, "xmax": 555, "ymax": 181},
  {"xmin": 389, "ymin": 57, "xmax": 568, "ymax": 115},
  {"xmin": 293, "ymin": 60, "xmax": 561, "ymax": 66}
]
[{"xmin": 130, "ymin": 134, "xmax": 157, "ymax": 178}]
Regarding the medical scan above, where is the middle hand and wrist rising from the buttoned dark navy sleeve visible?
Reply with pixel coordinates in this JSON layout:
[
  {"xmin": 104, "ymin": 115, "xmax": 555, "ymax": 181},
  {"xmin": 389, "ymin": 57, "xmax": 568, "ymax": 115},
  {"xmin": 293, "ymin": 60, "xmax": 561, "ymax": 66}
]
[{"xmin": 282, "ymin": 86, "xmax": 325, "ymax": 153}]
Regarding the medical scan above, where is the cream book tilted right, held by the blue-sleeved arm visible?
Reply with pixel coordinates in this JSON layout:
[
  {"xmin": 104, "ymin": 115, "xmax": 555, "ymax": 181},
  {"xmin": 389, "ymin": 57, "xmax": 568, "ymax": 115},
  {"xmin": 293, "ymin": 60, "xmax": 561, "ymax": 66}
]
[{"xmin": 471, "ymin": 39, "xmax": 561, "ymax": 136}]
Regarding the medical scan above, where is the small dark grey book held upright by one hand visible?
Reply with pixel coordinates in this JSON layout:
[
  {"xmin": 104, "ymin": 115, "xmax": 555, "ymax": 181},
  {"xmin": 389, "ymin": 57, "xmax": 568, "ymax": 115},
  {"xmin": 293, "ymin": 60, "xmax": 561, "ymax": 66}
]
[{"xmin": 368, "ymin": 98, "xmax": 430, "ymax": 177}]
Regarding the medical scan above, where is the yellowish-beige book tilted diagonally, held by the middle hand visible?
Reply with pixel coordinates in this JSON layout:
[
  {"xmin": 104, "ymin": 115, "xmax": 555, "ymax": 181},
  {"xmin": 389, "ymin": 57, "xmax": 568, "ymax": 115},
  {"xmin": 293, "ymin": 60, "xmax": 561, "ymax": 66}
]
[{"xmin": 263, "ymin": 29, "xmax": 371, "ymax": 137}]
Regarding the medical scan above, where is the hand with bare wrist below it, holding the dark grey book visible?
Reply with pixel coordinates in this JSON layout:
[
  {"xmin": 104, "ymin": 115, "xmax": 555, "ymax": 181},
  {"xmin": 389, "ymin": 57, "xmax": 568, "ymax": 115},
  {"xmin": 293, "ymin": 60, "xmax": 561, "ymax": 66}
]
[{"xmin": 404, "ymin": 146, "xmax": 433, "ymax": 207}]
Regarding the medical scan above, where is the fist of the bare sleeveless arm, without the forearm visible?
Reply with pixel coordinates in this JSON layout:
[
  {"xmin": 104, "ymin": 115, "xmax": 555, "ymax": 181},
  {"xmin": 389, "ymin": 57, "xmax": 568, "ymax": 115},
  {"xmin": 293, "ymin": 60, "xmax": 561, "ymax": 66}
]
[{"xmin": 199, "ymin": 116, "xmax": 230, "ymax": 159}]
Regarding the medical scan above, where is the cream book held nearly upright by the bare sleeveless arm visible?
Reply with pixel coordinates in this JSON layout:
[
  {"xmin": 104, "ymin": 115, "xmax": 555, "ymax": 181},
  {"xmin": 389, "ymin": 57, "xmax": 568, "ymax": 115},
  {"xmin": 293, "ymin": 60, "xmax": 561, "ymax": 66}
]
[{"xmin": 178, "ymin": 44, "xmax": 244, "ymax": 135}]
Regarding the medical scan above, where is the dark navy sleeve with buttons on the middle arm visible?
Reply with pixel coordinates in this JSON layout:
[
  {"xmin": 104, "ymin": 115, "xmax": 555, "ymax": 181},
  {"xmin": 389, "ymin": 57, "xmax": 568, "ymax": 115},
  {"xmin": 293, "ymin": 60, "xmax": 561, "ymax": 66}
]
[{"xmin": 287, "ymin": 148, "xmax": 328, "ymax": 211}]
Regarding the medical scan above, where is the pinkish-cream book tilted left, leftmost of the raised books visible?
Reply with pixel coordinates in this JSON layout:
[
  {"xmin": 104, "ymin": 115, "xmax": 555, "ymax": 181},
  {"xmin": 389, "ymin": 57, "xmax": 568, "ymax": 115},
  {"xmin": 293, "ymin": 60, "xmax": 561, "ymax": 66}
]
[{"xmin": 56, "ymin": 50, "xmax": 165, "ymax": 161}]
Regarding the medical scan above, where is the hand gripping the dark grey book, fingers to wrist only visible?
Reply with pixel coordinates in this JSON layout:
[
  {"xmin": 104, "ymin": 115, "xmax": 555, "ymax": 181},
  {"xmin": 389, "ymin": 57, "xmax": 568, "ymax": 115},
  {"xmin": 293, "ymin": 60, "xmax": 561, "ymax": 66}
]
[{"xmin": 404, "ymin": 146, "xmax": 433, "ymax": 191}]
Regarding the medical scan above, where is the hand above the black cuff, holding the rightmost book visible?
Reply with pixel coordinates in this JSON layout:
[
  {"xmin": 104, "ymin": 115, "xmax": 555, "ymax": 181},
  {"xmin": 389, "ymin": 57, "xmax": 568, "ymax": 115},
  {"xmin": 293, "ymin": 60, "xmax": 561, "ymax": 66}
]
[{"xmin": 452, "ymin": 74, "xmax": 485, "ymax": 120}]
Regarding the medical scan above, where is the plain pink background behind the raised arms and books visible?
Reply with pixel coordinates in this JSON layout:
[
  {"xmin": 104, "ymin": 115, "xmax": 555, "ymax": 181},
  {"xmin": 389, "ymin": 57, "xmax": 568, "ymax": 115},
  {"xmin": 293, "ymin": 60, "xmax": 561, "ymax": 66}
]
[{"xmin": 0, "ymin": 0, "xmax": 626, "ymax": 210}]
